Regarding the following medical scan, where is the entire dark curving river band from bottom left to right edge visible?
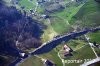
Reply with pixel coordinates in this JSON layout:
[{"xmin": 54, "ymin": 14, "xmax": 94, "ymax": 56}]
[{"xmin": 9, "ymin": 27, "xmax": 100, "ymax": 66}]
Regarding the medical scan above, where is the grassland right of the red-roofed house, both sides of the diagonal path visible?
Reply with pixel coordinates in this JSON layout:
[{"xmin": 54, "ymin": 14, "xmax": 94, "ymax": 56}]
[{"xmin": 65, "ymin": 40, "xmax": 96, "ymax": 66}]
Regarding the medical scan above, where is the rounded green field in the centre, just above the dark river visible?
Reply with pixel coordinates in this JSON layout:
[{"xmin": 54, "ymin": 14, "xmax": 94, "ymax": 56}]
[{"xmin": 51, "ymin": 17, "xmax": 73, "ymax": 34}]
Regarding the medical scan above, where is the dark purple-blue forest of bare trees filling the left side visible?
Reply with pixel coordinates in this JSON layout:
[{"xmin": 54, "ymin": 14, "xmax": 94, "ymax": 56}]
[{"xmin": 0, "ymin": 0, "xmax": 44, "ymax": 56}]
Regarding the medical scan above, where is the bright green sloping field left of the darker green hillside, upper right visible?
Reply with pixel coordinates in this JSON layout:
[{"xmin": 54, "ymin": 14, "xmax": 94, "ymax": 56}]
[{"xmin": 50, "ymin": 2, "xmax": 84, "ymax": 21}]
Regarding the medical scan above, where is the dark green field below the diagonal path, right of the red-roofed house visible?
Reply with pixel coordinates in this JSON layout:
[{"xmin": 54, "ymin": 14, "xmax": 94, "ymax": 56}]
[{"xmin": 65, "ymin": 42, "xmax": 96, "ymax": 66}]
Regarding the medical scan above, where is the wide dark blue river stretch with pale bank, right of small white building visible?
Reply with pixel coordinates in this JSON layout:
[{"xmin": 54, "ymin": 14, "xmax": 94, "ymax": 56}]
[{"xmin": 30, "ymin": 28, "xmax": 100, "ymax": 55}]
